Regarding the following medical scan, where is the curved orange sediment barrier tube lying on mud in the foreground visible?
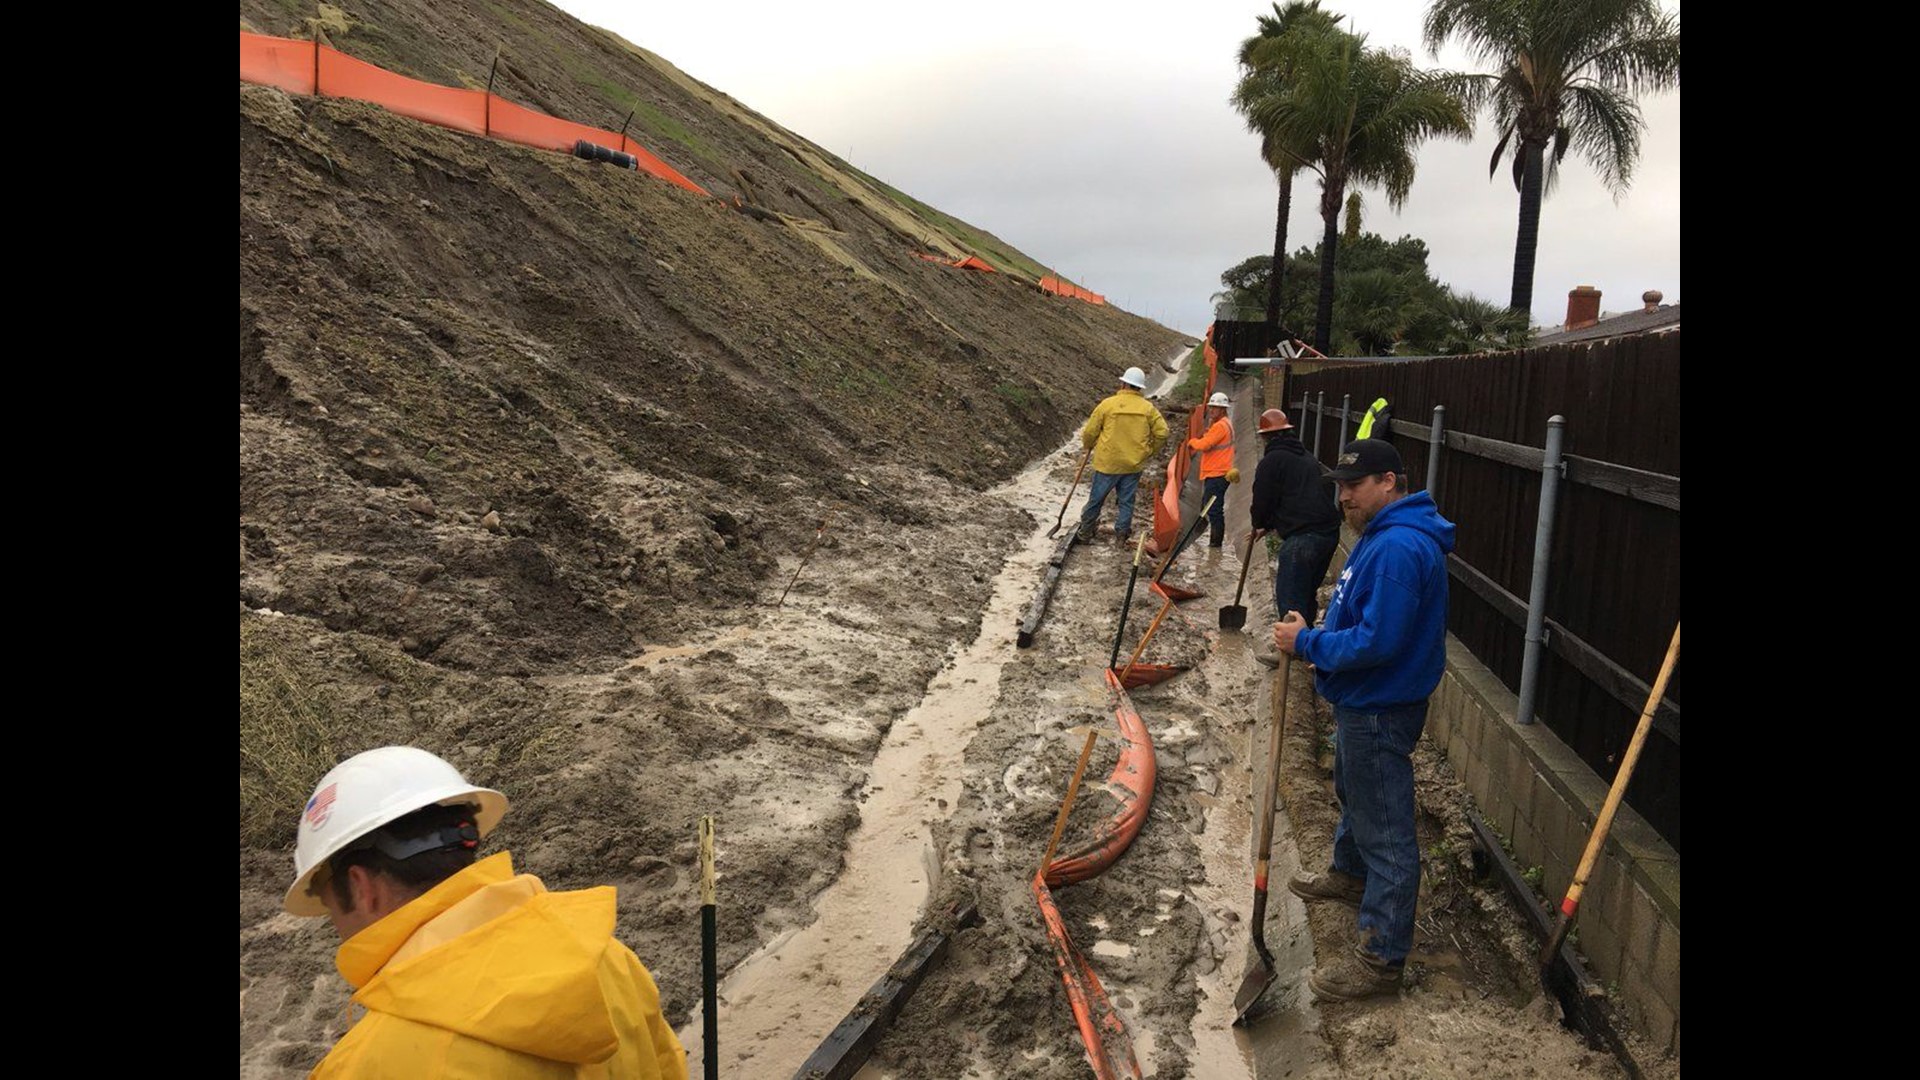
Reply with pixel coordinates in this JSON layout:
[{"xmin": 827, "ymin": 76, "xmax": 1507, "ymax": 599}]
[{"xmin": 1029, "ymin": 665, "xmax": 1160, "ymax": 1080}]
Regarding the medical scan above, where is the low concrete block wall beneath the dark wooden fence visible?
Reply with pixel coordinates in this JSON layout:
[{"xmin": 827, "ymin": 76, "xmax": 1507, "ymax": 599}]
[{"xmin": 1427, "ymin": 636, "xmax": 1680, "ymax": 1055}]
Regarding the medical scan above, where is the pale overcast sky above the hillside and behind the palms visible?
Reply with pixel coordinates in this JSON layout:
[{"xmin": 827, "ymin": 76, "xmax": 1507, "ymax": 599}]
[{"xmin": 557, "ymin": 0, "xmax": 1680, "ymax": 334}]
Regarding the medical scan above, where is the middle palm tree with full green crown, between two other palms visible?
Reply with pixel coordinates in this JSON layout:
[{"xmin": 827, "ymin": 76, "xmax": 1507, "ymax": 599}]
[{"xmin": 1248, "ymin": 31, "xmax": 1473, "ymax": 352}]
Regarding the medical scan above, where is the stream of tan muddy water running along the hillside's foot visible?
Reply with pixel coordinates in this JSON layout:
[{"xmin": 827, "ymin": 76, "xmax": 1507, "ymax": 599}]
[{"xmin": 679, "ymin": 442, "xmax": 1077, "ymax": 1078}]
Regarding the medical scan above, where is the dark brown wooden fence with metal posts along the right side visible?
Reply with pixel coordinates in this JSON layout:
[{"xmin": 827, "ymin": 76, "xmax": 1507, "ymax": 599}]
[{"xmin": 1286, "ymin": 331, "xmax": 1684, "ymax": 849}]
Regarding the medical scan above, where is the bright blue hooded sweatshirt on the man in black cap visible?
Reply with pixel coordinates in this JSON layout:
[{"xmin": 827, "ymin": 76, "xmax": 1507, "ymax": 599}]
[{"xmin": 1294, "ymin": 492, "xmax": 1453, "ymax": 709}]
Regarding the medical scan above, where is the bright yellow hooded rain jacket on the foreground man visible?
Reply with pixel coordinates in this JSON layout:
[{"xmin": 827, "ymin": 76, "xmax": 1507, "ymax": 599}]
[{"xmin": 313, "ymin": 851, "xmax": 687, "ymax": 1080}]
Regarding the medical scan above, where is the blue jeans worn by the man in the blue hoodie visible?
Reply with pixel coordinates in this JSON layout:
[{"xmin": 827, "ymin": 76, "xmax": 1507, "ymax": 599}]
[{"xmin": 1332, "ymin": 701, "xmax": 1427, "ymax": 965}]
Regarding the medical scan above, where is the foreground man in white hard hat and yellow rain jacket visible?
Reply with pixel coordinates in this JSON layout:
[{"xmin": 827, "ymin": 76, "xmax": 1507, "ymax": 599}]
[{"xmin": 284, "ymin": 746, "xmax": 687, "ymax": 1080}]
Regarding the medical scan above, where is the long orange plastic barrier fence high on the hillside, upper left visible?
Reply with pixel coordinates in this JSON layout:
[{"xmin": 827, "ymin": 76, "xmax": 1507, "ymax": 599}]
[{"xmin": 240, "ymin": 31, "xmax": 708, "ymax": 194}]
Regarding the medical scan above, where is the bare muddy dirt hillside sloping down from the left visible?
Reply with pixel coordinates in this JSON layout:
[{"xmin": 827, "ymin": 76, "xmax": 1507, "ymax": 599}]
[{"xmin": 240, "ymin": 0, "xmax": 1187, "ymax": 1076}]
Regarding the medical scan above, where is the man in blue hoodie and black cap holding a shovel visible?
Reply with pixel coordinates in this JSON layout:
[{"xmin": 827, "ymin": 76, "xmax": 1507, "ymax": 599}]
[{"xmin": 1273, "ymin": 438, "xmax": 1453, "ymax": 1001}]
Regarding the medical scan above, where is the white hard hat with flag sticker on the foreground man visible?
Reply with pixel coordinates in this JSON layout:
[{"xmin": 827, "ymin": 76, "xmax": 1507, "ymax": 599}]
[{"xmin": 280, "ymin": 746, "xmax": 507, "ymax": 915}]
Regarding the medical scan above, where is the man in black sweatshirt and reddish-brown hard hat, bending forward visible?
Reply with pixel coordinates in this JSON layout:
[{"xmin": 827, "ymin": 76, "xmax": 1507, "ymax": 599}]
[{"xmin": 1250, "ymin": 409, "xmax": 1340, "ymax": 667}]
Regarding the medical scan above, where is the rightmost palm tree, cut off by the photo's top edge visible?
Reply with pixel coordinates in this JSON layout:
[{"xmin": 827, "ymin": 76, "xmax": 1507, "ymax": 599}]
[{"xmin": 1425, "ymin": 0, "xmax": 1680, "ymax": 311}]
